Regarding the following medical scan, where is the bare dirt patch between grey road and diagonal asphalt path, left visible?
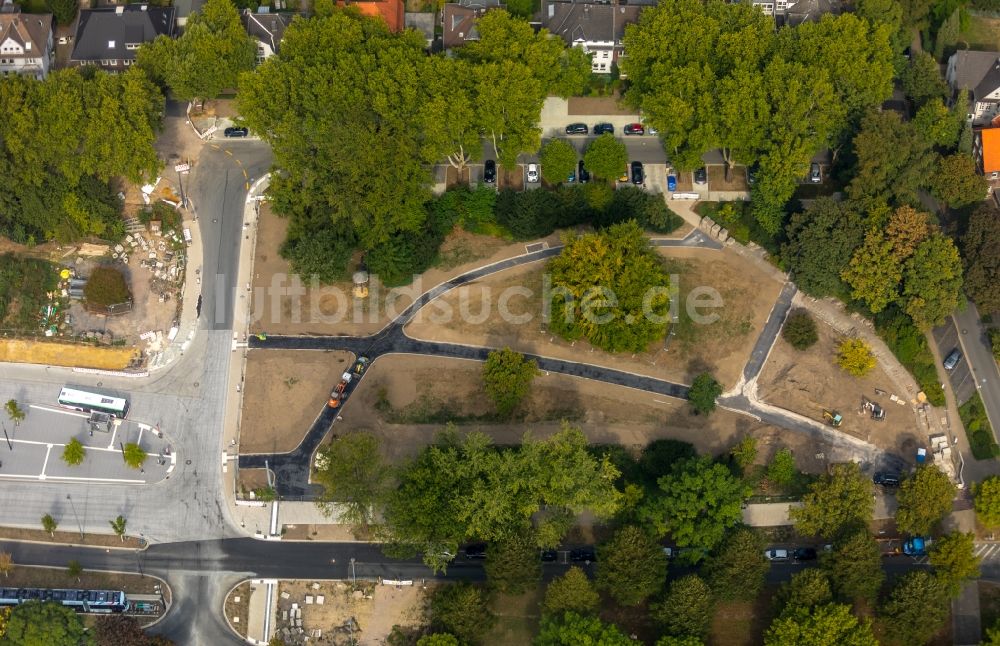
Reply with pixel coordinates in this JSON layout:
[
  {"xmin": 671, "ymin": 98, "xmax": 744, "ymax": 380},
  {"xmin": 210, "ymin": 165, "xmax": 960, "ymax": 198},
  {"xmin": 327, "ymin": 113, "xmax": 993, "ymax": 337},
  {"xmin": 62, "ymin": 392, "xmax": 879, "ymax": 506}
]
[{"xmin": 240, "ymin": 350, "xmax": 354, "ymax": 453}]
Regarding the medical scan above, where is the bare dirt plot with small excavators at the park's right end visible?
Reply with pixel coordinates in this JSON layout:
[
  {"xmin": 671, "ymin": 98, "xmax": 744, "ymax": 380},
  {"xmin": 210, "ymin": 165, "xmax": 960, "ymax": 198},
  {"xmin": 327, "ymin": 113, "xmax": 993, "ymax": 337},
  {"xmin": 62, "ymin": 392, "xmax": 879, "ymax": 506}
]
[{"xmin": 757, "ymin": 321, "xmax": 918, "ymax": 455}]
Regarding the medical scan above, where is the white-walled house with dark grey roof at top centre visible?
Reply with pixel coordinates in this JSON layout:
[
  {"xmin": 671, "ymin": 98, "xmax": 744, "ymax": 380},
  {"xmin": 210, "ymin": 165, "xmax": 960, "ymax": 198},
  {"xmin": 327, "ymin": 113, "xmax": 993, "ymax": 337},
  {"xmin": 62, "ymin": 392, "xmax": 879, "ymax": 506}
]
[{"xmin": 539, "ymin": 0, "xmax": 642, "ymax": 74}]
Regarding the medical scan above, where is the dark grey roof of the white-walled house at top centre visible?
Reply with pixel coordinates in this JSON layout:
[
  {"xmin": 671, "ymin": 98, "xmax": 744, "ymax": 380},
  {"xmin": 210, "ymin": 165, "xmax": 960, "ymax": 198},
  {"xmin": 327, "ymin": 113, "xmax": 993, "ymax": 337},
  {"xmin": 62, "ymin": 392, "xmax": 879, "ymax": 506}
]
[{"xmin": 540, "ymin": 0, "xmax": 642, "ymax": 45}]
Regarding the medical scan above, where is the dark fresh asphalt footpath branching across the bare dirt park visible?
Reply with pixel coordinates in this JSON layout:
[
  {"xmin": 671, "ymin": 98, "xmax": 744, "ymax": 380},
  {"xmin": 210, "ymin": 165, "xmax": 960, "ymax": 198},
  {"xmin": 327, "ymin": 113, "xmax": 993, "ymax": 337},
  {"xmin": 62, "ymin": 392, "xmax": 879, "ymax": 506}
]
[{"xmin": 239, "ymin": 230, "xmax": 722, "ymax": 500}]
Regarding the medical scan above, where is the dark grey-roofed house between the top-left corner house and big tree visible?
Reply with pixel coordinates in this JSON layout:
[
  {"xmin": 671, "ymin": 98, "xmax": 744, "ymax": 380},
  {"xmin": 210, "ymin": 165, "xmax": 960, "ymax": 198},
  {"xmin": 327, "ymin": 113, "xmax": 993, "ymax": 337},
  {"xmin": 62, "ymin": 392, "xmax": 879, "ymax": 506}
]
[{"xmin": 70, "ymin": 4, "xmax": 176, "ymax": 72}]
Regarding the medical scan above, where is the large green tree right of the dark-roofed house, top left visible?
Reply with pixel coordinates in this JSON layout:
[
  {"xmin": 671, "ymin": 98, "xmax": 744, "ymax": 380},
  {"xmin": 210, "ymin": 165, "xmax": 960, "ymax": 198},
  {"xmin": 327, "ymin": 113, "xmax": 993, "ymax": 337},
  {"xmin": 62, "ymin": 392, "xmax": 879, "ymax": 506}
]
[{"xmin": 138, "ymin": 0, "xmax": 257, "ymax": 101}]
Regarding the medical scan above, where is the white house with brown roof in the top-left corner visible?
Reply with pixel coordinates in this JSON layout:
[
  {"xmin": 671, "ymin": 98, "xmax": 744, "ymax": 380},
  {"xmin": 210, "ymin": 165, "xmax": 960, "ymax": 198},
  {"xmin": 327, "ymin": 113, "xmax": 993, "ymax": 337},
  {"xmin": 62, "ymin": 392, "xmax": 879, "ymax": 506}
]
[{"xmin": 0, "ymin": 0, "xmax": 52, "ymax": 80}]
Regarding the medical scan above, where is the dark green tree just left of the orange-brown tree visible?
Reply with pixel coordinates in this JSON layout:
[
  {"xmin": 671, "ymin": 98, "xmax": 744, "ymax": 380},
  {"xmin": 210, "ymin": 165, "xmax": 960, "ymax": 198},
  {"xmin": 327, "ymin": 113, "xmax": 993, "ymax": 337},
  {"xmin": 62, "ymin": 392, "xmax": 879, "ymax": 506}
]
[{"xmin": 781, "ymin": 197, "xmax": 865, "ymax": 298}]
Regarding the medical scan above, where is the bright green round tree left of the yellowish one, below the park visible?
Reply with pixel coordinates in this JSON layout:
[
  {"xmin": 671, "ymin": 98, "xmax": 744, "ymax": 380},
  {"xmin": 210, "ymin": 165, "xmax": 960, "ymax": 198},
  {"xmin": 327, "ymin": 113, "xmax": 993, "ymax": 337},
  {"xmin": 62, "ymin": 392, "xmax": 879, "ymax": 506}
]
[{"xmin": 639, "ymin": 457, "xmax": 750, "ymax": 559}]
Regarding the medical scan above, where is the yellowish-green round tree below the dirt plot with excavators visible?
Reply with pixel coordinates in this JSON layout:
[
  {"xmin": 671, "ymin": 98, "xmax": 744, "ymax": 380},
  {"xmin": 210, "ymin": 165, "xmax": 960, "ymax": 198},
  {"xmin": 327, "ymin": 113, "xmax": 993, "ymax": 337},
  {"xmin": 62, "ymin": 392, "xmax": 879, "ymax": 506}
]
[{"xmin": 789, "ymin": 462, "xmax": 875, "ymax": 537}]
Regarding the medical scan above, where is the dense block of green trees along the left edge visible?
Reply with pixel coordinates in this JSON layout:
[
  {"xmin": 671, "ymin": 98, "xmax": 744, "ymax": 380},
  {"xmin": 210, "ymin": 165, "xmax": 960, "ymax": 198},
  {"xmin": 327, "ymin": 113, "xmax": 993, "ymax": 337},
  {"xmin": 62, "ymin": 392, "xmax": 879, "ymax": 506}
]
[{"xmin": 0, "ymin": 69, "xmax": 164, "ymax": 244}]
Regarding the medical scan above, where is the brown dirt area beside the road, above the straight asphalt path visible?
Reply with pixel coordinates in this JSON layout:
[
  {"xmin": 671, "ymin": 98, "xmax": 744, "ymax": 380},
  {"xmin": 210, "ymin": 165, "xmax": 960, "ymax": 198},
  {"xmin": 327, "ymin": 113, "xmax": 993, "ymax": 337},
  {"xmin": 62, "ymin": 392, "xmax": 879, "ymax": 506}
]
[{"xmin": 251, "ymin": 202, "xmax": 559, "ymax": 335}]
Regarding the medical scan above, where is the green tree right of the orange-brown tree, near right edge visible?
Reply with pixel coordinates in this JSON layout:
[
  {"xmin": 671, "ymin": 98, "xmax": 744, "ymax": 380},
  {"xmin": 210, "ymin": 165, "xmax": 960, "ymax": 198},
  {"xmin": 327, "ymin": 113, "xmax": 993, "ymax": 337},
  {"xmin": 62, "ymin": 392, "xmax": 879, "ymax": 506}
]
[{"xmin": 901, "ymin": 234, "xmax": 962, "ymax": 330}]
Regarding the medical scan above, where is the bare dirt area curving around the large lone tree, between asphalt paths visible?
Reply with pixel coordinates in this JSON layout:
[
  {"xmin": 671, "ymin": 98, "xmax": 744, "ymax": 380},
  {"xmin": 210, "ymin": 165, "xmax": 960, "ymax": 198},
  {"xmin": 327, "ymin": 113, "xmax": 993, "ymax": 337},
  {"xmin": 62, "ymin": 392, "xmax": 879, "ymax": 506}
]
[{"xmin": 406, "ymin": 249, "xmax": 781, "ymax": 387}]
